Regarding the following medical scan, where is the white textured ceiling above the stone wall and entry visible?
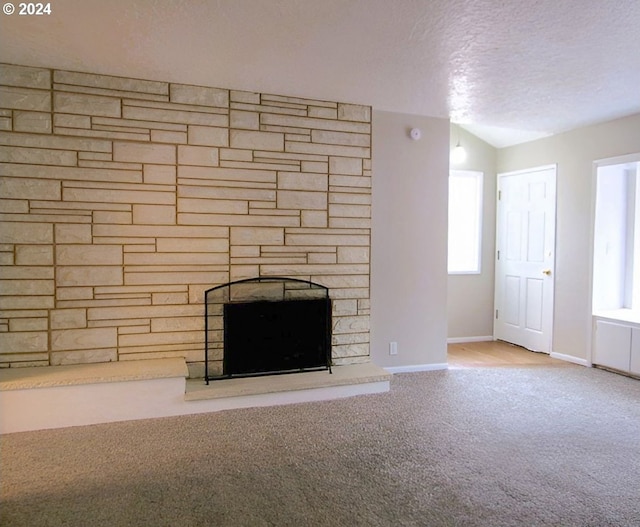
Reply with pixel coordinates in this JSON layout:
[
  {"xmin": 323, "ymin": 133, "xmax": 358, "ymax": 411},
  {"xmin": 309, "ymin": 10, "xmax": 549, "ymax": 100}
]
[{"xmin": 0, "ymin": 0, "xmax": 640, "ymax": 147}]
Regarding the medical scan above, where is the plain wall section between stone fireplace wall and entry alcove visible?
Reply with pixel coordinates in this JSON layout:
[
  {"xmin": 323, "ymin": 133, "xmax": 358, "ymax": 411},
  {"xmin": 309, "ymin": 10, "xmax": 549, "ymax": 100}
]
[{"xmin": 371, "ymin": 111, "xmax": 449, "ymax": 368}]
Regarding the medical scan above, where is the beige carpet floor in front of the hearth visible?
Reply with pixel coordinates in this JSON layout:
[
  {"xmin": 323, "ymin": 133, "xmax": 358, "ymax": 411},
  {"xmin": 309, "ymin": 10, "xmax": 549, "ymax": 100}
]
[{"xmin": 0, "ymin": 366, "xmax": 640, "ymax": 527}]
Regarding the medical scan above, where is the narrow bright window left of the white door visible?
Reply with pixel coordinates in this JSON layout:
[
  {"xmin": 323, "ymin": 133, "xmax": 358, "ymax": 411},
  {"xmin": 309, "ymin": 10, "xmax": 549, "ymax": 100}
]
[{"xmin": 448, "ymin": 170, "xmax": 482, "ymax": 274}]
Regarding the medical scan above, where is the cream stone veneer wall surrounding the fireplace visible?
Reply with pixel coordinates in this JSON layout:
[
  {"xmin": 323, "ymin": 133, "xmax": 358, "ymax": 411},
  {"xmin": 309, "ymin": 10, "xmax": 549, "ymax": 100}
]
[{"xmin": 0, "ymin": 65, "xmax": 371, "ymax": 376}]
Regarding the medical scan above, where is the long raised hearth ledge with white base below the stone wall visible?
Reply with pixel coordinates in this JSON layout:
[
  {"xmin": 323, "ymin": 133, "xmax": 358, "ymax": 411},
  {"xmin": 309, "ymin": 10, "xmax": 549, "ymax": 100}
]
[{"xmin": 0, "ymin": 358, "xmax": 391, "ymax": 434}]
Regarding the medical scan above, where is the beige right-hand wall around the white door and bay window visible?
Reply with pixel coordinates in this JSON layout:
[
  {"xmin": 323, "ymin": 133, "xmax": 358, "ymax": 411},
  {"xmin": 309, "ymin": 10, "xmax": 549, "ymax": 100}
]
[{"xmin": 497, "ymin": 114, "xmax": 640, "ymax": 360}]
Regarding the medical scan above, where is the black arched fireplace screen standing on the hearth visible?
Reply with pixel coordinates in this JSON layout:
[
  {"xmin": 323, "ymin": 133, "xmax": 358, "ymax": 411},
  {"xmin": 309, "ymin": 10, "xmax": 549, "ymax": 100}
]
[{"xmin": 205, "ymin": 277, "xmax": 331, "ymax": 384}]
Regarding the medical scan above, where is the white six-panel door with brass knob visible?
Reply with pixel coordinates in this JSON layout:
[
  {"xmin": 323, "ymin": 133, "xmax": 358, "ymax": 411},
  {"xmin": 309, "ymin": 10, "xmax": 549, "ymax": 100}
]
[{"xmin": 494, "ymin": 166, "xmax": 556, "ymax": 353}]
